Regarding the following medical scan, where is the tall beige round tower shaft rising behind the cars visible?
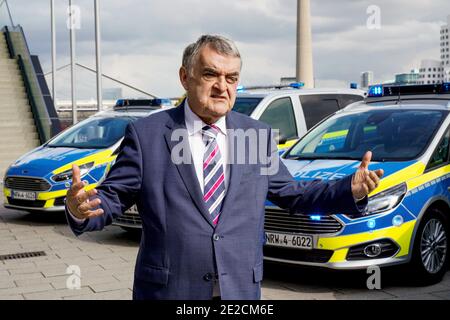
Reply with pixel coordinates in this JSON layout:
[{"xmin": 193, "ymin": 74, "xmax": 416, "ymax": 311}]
[{"xmin": 296, "ymin": 0, "xmax": 314, "ymax": 88}]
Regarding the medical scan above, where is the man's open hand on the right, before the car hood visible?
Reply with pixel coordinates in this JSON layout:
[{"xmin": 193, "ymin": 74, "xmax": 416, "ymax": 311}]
[{"xmin": 352, "ymin": 151, "xmax": 384, "ymax": 199}]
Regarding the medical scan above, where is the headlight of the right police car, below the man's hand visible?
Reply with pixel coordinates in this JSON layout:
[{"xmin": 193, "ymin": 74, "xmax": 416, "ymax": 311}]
[{"xmin": 365, "ymin": 182, "xmax": 408, "ymax": 215}]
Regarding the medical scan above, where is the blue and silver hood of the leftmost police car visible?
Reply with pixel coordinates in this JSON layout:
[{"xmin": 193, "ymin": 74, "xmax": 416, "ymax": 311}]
[{"xmin": 7, "ymin": 146, "xmax": 103, "ymax": 177}]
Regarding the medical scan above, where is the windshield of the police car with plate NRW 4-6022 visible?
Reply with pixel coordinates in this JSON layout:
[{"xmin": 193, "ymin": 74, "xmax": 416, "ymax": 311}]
[{"xmin": 285, "ymin": 109, "xmax": 446, "ymax": 161}]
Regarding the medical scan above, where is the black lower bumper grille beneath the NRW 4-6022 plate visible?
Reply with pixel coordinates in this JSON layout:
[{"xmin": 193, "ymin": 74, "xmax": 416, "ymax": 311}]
[{"xmin": 263, "ymin": 246, "xmax": 333, "ymax": 263}]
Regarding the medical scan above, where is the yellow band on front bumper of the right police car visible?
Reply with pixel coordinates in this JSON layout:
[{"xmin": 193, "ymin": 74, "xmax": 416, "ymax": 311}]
[{"xmin": 317, "ymin": 220, "xmax": 416, "ymax": 262}]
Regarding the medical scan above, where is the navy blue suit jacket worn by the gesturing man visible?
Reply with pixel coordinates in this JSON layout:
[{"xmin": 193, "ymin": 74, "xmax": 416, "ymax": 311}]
[{"xmin": 66, "ymin": 107, "xmax": 365, "ymax": 299}]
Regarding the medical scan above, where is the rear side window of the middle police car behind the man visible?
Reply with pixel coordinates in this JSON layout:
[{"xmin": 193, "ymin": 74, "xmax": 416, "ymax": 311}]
[{"xmin": 299, "ymin": 94, "xmax": 339, "ymax": 130}]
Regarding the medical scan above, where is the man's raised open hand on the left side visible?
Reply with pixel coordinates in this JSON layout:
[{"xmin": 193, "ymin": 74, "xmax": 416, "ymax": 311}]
[{"xmin": 66, "ymin": 164, "xmax": 103, "ymax": 219}]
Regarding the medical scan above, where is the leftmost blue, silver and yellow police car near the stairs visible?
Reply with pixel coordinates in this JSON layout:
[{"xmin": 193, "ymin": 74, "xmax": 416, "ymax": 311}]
[{"xmin": 3, "ymin": 99, "xmax": 167, "ymax": 212}]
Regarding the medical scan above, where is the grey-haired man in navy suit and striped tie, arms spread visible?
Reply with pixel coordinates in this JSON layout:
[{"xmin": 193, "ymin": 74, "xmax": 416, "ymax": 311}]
[{"xmin": 66, "ymin": 35, "xmax": 383, "ymax": 299}]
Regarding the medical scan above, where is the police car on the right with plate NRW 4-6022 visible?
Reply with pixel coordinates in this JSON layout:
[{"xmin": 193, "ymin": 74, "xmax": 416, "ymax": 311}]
[{"xmin": 264, "ymin": 84, "xmax": 450, "ymax": 283}]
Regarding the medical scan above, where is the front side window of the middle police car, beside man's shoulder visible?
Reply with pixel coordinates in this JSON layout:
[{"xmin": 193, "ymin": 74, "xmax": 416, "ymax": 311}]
[{"xmin": 259, "ymin": 97, "xmax": 297, "ymax": 140}]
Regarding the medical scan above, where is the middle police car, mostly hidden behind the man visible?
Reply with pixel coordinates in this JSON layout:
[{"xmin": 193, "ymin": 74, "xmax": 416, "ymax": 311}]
[{"xmin": 114, "ymin": 82, "xmax": 365, "ymax": 229}]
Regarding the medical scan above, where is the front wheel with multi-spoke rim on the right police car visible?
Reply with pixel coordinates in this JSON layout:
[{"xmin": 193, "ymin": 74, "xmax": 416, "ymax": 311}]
[{"xmin": 411, "ymin": 209, "xmax": 450, "ymax": 285}]
